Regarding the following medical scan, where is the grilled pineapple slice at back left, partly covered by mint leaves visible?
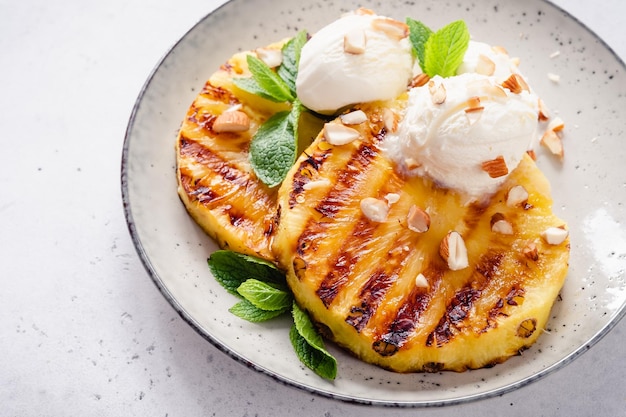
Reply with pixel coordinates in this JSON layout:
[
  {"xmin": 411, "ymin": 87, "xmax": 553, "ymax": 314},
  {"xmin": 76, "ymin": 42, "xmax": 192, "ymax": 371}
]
[{"xmin": 176, "ymin": 42, "xmax": 289, "ymax": 260}]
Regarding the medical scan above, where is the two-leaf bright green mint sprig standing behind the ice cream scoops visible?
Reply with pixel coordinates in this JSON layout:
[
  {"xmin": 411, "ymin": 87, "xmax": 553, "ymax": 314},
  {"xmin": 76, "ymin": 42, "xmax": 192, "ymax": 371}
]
[{"xmin": 407, "ymin": 18, "xmax": 470, "ymax": 77}]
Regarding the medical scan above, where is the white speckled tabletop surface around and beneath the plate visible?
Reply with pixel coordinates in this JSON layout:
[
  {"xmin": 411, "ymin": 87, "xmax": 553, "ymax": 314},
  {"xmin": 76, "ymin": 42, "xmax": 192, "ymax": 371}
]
[{"xmin": 0, "ymin": 0, "xmax": 626, "ymax": 417}]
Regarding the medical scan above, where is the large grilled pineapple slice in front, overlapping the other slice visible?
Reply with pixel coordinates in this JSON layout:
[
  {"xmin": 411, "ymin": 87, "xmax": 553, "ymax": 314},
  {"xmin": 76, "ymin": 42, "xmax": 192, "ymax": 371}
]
[{"xmin": 272, "ymin": 100, "xmax": 569, "ymax": 372}]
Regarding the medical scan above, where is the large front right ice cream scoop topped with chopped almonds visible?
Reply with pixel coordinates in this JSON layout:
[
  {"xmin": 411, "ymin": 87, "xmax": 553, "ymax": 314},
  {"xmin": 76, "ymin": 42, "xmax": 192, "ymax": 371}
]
[{"xmin": 386, "ymin": 73, "xmax": 538, "ymax": 201}]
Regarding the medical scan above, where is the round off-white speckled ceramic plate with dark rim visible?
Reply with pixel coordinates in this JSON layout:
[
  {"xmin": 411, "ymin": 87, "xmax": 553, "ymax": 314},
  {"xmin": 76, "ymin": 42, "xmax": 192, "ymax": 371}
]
[{"xmin": 122, "ymin": 0, "xmax": 626, "ymax": 406}]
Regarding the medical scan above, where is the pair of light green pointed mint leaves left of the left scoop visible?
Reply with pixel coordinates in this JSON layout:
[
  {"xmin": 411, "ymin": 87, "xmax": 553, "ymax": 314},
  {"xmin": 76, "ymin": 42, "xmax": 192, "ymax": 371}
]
[{"xmin": 234, "ymin": 55, "xmax": 295, "ymax": 103}]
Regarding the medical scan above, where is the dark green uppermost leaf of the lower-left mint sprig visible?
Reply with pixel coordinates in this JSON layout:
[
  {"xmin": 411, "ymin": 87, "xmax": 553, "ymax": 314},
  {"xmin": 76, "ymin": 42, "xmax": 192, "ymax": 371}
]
[{"xmin": 207, "ymin": 250, "xmax": 285, "ymax": 296}]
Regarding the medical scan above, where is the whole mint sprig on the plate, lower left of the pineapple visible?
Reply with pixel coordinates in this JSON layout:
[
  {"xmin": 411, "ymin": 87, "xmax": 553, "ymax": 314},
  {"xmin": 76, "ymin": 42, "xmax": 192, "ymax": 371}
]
[{"xmin": 208, "ymin": 250, "xmax": 337, "ymax": 379}]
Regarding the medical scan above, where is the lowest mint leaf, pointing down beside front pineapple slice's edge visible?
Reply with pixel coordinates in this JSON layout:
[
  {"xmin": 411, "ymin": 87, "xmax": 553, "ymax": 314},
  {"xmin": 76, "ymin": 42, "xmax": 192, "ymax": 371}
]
[{"xmin": 289, "ymin": 302, "xmax": 337, "ymax": 379}]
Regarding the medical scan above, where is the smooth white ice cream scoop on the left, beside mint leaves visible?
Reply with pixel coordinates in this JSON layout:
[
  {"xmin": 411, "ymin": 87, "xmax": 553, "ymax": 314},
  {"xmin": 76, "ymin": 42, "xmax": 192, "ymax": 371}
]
[{"xmin": 296, "ymin": 13, "xmax": 413, "ymax": 114}]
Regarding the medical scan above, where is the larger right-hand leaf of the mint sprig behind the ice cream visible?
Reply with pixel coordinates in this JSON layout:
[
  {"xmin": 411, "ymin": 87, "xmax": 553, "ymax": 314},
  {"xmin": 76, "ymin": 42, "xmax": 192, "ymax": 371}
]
[{"xmin": 424, "ymin": 20, "xmax": 470, "ymax": 77}]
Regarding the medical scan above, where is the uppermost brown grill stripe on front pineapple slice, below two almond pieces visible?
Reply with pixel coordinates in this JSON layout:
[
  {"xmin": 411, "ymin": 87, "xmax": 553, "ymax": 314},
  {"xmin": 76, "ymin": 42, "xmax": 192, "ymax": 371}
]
[{"xmin": 315, "ymin": 143, "xmax": 378, "ymax": 219}]
